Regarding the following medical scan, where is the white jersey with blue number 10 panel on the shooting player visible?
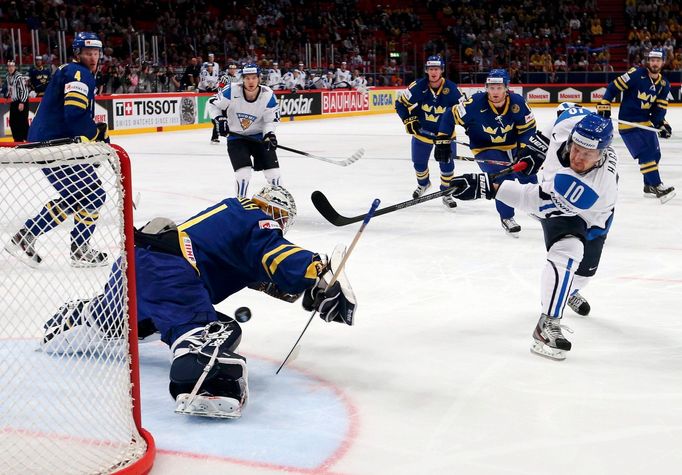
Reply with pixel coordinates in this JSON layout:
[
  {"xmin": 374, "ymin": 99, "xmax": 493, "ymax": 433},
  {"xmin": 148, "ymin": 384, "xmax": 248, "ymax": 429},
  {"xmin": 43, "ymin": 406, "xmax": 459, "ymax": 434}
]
[{"xmin": 496, "ymin": 108, "xmax": 618, "ymax": 229}]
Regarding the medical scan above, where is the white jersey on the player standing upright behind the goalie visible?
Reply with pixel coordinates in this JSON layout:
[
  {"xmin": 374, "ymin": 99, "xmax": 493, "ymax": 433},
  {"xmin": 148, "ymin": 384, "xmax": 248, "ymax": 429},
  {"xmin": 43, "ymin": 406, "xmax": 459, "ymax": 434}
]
[{"xmin": 206, "ymin": 83, "xmax": 279, "ymax": 135}]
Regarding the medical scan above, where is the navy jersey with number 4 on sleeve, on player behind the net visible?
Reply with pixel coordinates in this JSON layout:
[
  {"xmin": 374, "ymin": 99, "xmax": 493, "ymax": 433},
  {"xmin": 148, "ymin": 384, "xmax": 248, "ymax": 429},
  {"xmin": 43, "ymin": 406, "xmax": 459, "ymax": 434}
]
[{"xmin": 28, "ymin": 62, "xmax": 97, "ymax": 142}]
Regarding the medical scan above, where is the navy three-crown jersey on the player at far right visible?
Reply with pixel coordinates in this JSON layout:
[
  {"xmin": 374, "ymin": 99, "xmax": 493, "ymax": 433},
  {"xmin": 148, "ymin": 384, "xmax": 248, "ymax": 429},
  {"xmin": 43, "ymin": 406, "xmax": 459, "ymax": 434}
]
[{"xmin": 603, "ymin": 67, "xmax": 670, "ymax": 131}]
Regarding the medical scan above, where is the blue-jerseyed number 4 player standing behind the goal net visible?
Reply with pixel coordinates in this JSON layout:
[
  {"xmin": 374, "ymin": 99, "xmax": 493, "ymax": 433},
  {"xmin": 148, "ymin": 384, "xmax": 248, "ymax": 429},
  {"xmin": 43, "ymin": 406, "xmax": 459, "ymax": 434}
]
[{"xmin": 5, "ymin": 33, "xmax": 108, "ymax": 267}]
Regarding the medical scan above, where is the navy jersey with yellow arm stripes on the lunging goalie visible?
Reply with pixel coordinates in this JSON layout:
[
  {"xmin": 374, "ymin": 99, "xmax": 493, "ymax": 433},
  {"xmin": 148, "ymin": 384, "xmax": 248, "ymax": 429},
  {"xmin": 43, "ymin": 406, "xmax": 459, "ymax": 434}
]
[{"xmin": 173, "ymin": 198, "xmax": 319, "ymax": 304}]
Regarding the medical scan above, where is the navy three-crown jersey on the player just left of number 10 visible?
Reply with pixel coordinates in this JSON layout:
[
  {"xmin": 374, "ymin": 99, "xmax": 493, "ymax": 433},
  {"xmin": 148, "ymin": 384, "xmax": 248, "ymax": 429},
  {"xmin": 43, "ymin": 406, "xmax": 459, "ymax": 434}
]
[{"xmin": 438, "ymin": 92, "xmax": 536, "ymax": 155}]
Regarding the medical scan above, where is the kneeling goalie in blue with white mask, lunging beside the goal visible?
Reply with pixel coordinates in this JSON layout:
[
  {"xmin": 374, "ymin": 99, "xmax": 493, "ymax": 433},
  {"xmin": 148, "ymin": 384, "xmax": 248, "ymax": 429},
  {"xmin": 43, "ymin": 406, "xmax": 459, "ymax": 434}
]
[{"xmin": 42, "ymin": 186, "xmax": 355, "ymax": 418}]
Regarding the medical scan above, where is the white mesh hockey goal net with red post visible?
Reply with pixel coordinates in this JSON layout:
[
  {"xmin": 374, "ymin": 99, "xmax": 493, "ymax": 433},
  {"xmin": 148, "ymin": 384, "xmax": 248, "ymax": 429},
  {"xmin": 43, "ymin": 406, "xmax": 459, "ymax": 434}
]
[{"xmin": 0, "ymin": 143, "xmax": 154, "ymax": 474}]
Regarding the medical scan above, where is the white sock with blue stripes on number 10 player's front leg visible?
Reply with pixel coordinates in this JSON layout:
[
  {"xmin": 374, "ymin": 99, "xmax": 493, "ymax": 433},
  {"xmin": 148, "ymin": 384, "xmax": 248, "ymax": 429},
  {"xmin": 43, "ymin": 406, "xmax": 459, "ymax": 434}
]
[{"xmin": 540, "ymin": 236, "xmax": 583, "ymax": 318}]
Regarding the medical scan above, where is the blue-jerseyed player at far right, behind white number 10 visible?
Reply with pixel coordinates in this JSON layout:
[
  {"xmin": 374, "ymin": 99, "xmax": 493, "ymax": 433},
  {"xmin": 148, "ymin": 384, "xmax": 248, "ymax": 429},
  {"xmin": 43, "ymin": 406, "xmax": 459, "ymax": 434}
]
[{"xmin": 597, "ymin": 48, "xmax": 675, "ymax": 203}]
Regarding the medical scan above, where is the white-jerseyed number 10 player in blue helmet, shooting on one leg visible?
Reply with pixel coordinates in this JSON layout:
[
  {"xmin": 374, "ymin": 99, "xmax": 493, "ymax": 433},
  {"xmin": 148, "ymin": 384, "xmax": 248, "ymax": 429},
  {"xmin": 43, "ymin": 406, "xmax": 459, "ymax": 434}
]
[{"xmin": 452, "ymin": 107, "xmax": 618, "ymax": 360}]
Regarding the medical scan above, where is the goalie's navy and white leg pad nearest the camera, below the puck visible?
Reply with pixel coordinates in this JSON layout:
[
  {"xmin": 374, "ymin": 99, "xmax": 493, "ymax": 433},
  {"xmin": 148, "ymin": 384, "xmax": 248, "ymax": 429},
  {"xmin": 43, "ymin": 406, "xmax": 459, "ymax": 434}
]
[{"xmin": 169, "ymin": 319, "xmax": 249, "ymax": 418}]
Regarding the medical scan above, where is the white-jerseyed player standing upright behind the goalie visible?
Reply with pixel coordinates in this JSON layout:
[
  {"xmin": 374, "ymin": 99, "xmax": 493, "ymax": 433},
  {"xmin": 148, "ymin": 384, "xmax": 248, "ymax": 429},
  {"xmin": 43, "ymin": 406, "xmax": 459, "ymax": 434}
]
[{"xmin": 207, "ymin": 64, "xmax": 281, "ymax": 198}]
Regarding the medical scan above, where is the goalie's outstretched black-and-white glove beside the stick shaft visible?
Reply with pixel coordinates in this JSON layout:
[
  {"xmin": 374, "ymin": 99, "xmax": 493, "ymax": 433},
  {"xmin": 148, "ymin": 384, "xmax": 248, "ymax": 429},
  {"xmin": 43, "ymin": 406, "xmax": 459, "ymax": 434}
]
[{"xmin": 303, "ymin": 244, "xmax": 357, "ymax": 325}]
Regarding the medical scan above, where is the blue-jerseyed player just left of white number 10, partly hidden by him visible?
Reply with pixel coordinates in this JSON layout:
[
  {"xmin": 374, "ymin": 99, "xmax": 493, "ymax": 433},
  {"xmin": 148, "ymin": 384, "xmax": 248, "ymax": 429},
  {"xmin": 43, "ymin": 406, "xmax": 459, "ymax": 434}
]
[{"xmin": 435, "ymin": 69, "xmax": 536, "ymax": 237}]
